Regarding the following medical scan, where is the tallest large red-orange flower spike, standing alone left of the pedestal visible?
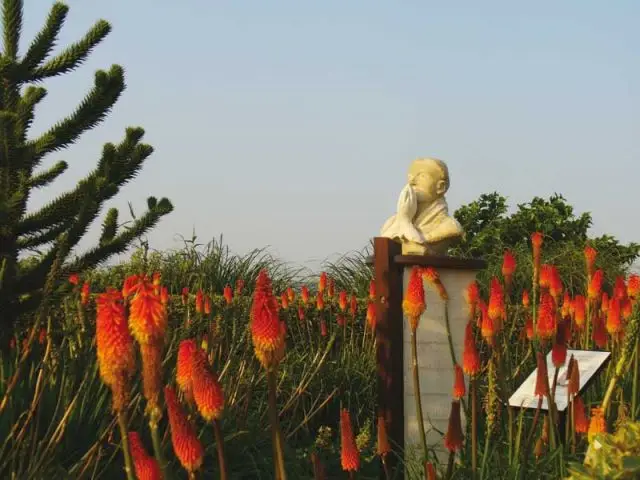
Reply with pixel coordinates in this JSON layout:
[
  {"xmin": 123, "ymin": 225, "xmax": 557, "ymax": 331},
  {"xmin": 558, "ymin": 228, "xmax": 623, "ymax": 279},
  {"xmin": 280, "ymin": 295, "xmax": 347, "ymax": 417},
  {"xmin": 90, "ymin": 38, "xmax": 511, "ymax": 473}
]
[{"xmin": 250, "ymin": 270, "xmax": 286, "ymax": 368}]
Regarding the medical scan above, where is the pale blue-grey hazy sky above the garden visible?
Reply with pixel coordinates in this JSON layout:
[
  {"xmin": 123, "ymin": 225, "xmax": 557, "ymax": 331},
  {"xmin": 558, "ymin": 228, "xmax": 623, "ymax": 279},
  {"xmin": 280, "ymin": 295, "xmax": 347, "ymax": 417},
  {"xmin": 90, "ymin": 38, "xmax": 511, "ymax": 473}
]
[{"xmin": 22, "ymin": 0, "xmax": 640, "ymax": 267}]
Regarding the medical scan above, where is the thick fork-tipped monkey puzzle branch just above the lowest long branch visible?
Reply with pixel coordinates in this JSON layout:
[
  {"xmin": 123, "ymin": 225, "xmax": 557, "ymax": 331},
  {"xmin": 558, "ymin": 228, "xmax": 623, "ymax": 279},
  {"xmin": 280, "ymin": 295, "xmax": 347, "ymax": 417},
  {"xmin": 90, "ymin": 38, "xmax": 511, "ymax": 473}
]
[{"xmin": 16, "ymin": 128, "xmax": 153, "ymax": 235}]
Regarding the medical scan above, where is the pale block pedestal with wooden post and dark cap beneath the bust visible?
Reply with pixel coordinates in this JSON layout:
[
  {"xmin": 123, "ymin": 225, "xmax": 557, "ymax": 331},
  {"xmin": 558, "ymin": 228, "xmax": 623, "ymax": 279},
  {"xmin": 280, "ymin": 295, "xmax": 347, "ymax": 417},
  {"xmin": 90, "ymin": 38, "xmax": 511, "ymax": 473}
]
[{"xmin": 374, "ymin": 237, "xmax": 485, "ymax": 478}]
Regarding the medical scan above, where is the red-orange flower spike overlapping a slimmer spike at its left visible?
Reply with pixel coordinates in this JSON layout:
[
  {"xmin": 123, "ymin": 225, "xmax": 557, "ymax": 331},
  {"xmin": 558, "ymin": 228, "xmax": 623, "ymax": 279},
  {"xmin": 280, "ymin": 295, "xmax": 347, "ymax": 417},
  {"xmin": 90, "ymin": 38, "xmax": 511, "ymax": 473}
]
[{"xmin": 192, "ymin": 348, "xmax": 224, "ymax": 422}]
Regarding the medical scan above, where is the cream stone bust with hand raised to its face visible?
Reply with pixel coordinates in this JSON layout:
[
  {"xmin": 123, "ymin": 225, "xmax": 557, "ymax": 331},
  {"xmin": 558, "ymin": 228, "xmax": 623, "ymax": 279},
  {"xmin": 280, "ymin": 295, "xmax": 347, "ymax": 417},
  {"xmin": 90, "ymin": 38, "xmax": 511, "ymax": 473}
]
[{"xmin": 380, "ymin": 158, "xmax": 464, "ymax": 255}]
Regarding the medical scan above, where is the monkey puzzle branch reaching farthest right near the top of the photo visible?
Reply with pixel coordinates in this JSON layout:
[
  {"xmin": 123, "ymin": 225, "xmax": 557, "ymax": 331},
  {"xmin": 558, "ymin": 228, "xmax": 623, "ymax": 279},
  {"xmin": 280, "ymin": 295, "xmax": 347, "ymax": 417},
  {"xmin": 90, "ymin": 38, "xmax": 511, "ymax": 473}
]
[{"xmin": 28, "ymin": 18, "xmax": 111, "ymax": 82}]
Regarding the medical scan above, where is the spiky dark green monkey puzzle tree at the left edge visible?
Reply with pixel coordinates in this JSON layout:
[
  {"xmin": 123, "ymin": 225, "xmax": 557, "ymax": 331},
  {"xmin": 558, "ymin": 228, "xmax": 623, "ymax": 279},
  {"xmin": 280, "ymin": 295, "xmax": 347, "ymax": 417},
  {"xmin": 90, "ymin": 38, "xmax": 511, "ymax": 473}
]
[{"xmin": 0, "ymin": 0, "xmax": 173, "ymax": 334}]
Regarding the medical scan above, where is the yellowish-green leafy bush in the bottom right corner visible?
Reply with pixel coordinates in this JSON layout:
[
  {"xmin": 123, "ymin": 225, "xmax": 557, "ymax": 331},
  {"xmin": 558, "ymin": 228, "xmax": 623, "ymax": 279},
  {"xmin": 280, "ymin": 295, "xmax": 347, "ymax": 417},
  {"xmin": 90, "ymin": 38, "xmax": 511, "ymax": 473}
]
[{"xmin": 567, "ymin": 421, "xmax": 640, "ymax": 480}]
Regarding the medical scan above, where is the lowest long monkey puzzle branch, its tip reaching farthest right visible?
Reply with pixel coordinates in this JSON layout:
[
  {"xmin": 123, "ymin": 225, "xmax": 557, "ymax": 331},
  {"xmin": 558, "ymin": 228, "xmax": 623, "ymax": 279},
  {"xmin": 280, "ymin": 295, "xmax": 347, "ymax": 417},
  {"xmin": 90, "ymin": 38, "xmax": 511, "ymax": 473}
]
[{"xmin": 65, "ymin": 198, "xmax": 173, "ymax": 274}]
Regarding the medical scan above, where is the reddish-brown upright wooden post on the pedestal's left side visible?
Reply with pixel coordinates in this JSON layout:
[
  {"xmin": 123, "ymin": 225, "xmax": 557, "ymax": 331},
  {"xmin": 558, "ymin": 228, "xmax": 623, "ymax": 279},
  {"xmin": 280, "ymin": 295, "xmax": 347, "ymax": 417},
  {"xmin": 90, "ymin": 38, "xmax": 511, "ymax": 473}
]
[{"xmin": 373, "ymin": 237, "xmax": 404, "ymax": 478}]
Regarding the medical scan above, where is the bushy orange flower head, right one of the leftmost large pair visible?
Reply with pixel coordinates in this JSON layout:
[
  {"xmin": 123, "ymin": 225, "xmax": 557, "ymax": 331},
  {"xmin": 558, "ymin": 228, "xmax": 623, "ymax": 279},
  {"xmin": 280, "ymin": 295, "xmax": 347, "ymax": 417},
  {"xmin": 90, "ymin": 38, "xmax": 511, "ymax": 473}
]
[{"xmin": 129, "ymin": 281, "xmax": 167, "ymax": 345}]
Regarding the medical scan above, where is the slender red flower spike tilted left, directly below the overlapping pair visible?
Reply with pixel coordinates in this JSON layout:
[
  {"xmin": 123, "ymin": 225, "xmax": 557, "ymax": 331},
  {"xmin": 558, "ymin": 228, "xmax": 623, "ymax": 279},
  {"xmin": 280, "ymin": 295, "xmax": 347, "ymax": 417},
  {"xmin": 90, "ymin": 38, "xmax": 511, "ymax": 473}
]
[{"xmin": 164, "ymin": 387, "xmax": 204, "ymax": 473}]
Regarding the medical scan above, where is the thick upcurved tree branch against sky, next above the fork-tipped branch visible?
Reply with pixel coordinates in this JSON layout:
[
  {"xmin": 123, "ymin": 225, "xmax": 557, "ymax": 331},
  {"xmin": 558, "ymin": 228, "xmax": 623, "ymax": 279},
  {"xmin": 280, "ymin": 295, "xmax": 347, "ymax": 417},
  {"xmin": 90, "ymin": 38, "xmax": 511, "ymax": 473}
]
[{"xmin": 31, "ymin": 65, "xmax": 125, "ymax": 167}]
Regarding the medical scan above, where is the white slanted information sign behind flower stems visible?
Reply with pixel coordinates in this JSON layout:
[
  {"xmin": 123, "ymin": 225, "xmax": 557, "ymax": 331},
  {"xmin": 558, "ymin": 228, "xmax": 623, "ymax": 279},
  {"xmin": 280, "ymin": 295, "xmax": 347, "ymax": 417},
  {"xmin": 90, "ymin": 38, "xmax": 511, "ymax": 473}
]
[{"xmin": 509, "ymin": 350, "xmax": 611, "ymax": 412}]
